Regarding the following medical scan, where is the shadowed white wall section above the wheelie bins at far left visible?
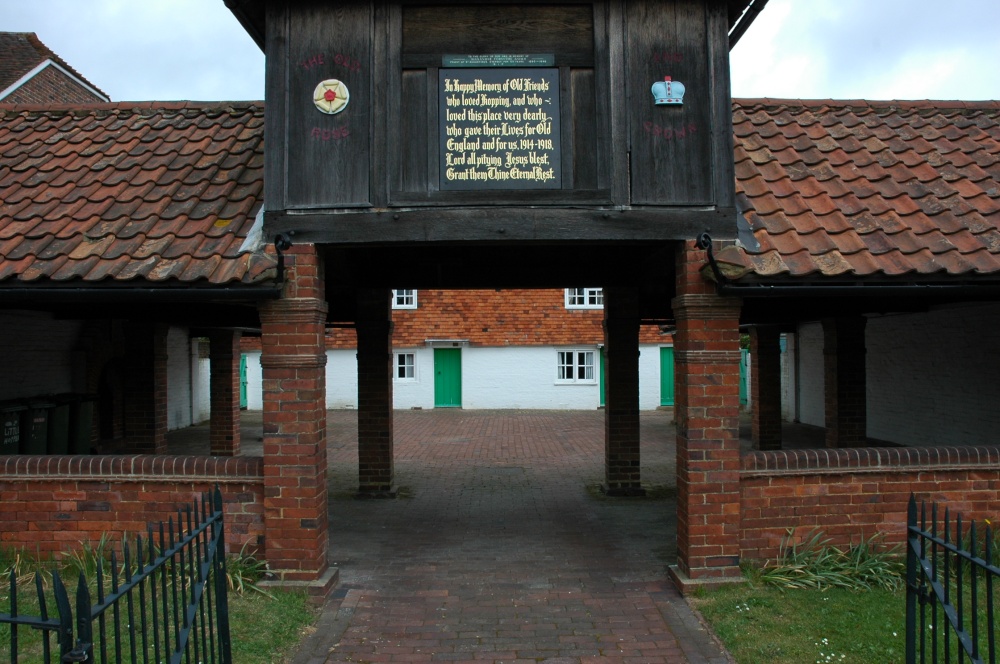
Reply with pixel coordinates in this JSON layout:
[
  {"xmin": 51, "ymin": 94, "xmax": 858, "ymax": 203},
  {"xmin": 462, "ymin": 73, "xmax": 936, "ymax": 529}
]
[{"xmin": 0, "ymin": 311, "xmax": 81, "ymax": 400}]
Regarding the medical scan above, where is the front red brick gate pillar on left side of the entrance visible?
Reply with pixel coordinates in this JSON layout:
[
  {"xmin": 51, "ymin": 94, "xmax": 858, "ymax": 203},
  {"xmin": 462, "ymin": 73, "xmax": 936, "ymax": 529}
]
[{"xmin": 260, "ymin": 245, "xmax": 335, "ymax": 594}]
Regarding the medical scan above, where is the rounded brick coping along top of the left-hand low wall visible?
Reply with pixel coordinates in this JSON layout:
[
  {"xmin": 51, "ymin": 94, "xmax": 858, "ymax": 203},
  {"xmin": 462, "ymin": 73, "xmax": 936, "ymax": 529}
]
[{"xmin": 0, "ymin": 454, "xmax": 264, "ymax": 483}]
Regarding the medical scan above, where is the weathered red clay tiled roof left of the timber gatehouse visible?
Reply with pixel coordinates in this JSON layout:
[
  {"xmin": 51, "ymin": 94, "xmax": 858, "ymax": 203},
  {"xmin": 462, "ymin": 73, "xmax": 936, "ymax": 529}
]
[{"xmin": 0, "ymin": 102, "xmax": 275, "ymax": 288}]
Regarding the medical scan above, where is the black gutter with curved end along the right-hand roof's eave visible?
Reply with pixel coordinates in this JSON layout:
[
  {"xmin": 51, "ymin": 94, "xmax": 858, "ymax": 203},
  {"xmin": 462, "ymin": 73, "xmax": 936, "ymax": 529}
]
[{"xmin": 695, "ymin": 233, "xmax": 1000, "ymax": 298}]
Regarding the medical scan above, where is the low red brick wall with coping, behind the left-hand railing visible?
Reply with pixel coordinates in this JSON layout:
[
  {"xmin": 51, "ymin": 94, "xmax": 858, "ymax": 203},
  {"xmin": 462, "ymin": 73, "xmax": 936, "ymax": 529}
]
[{"xmin": 0, "ymin": 455, "xmax": 264, "ymax": 557}]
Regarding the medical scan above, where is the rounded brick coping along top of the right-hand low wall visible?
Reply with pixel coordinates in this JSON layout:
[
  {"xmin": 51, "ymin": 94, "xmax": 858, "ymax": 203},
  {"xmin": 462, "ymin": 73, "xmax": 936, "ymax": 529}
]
[{"xmin": 740, "ymin": 446, "xmax": 1000, "ymax": 477}]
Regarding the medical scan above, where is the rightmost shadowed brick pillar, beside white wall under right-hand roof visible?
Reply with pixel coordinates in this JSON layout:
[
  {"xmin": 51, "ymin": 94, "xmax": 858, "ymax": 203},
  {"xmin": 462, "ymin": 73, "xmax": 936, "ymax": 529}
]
[{"xmin": 823, "ymin": 316, "xmax": 868, "ymax": 447}]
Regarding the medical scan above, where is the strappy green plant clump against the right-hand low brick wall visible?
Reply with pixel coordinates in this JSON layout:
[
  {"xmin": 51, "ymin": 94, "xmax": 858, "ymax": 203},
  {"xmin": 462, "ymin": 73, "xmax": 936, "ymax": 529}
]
[{"xmin": 759, "ymin": 530, "xmax": 905, "ymax": 590}]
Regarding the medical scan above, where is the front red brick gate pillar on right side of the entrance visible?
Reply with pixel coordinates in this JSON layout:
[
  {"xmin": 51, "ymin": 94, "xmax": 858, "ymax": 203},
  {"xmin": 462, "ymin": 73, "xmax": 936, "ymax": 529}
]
[{"xmin": 670, "ymin": 243, "xmax": 741, "ymax": 592}]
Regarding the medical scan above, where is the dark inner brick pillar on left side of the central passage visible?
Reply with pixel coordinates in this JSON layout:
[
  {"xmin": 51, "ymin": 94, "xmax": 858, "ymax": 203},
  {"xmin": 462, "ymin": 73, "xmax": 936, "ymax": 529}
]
[{"xmin": 357, "ymin": 288, "xmax": 396, "ymax": 497}]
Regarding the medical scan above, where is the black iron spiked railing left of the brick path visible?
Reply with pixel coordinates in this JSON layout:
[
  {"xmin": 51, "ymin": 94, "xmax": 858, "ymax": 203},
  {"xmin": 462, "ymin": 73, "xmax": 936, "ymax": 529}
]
[{"xmin": 0, "ymin": 488, "xmax": 232, "ymax": 664}]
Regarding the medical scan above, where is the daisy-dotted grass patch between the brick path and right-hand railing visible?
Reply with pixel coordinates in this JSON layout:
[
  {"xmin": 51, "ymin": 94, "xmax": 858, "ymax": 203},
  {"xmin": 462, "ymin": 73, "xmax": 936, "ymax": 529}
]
[{"xmin": 691, "ymin": 583, "xmax": 906, "ymax": 664}]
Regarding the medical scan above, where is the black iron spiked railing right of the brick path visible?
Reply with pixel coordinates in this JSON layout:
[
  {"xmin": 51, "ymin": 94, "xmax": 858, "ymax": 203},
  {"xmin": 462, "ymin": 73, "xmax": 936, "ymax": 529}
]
[{"xmin": 906, "ymin": 496, "xmax": 1000, "ymax": 664}]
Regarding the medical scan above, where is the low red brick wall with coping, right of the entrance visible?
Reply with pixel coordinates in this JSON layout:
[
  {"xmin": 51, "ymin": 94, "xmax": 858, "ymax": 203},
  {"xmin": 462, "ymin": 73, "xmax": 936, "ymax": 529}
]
[{"xmin": 740, "ymin": 447, "xmax": 1000, "ymax": 562}]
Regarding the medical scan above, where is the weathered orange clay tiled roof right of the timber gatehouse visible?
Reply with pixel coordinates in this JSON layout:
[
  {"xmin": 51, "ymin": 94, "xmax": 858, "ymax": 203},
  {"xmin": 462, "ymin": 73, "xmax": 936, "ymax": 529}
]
[{"xmin": 717, "ymin": 99, "xmax": 1000, "ymax": 282}]
